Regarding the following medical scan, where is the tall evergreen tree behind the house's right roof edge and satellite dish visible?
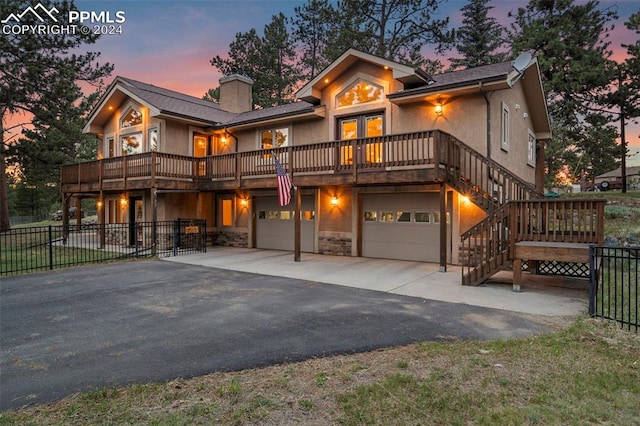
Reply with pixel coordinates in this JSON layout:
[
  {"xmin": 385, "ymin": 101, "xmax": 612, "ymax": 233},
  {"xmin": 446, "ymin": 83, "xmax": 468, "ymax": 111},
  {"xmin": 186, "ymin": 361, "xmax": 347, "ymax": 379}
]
[{"xmin": 511, "ymin": 0, "xmax": 616, "ymax": 185}]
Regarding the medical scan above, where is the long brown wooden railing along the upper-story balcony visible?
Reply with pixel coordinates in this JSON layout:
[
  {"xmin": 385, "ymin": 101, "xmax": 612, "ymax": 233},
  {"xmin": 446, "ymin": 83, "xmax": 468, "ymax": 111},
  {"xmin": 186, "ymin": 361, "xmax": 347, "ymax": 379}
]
[{"xmin": 61, "ymin": 131, "xmax": 446, "ymax": 185}]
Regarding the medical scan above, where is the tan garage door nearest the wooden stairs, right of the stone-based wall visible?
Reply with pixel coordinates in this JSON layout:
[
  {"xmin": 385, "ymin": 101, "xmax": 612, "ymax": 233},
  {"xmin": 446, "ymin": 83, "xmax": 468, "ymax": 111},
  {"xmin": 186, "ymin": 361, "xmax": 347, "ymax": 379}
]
[{"xmin": 361, "ymin": 193, "xmax": 450, "ymax": 262}]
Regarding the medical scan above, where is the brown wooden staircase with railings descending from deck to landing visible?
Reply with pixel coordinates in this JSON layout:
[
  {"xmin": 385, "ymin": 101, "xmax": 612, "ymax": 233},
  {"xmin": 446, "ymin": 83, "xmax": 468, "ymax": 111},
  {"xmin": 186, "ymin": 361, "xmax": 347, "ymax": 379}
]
[{"xmin": 439, "ymin": 134, "xmax": 606, "ymax": 285}]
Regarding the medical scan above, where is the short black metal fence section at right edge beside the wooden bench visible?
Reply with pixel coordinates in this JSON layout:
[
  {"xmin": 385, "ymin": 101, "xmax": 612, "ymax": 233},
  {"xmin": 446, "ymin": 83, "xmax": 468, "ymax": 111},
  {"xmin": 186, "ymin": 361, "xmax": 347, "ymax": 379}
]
[{"xmin": 589, "ymin": 246, "xmax": 640, "ymax": 332}]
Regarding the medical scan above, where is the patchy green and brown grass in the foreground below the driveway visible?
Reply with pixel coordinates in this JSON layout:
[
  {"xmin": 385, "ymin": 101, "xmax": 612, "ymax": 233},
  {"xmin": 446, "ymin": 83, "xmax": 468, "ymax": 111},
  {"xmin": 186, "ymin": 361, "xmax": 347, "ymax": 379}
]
[{"xmin": 0, "ymin": 319, "xmax": 640, "ymax": 425}]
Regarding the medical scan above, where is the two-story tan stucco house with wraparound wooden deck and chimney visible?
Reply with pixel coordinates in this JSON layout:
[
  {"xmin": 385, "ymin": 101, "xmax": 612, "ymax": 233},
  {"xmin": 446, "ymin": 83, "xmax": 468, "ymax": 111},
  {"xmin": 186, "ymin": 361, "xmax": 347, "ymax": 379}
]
[{"xmin": 61, "ymin": 49, "xmax": 604, "ymax": 282}]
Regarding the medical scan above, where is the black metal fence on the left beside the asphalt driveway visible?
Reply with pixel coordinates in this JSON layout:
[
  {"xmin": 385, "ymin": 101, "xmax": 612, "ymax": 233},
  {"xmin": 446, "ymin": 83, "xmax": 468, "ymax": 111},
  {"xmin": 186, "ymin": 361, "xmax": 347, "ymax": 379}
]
[{"xmin": 0, "ymin": 219, "xmax": 207, "ymax": 276}]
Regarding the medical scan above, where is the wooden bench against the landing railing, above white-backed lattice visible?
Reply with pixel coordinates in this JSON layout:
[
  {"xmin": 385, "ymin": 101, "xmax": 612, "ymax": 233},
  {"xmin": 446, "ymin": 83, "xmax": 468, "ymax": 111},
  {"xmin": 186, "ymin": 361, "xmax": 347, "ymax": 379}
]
[{"xmin": 513, "ymin": 241, "xmax": 589, "ymax": 291}]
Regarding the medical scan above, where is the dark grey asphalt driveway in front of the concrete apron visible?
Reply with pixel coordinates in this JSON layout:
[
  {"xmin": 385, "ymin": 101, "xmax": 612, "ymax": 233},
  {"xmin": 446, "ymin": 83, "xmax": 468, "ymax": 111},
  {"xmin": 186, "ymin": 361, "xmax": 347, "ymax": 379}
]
[{"xmin": 0, "ymin": 260, "xmax": 560, "ymax": 410}]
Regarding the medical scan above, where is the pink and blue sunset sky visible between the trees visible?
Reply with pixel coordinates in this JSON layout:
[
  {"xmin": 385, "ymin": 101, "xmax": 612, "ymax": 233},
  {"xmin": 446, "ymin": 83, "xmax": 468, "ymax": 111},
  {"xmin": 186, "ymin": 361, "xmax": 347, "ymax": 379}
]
[{"xmin": 8, "ymin": 0, "xmax": 640, "ymax": 152}]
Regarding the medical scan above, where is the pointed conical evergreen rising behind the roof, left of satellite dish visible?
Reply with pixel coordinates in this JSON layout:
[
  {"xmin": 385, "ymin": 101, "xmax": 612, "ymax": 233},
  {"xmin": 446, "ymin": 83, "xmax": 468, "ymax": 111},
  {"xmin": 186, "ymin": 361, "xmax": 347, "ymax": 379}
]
[{"xmin": 449, "ymin": 0, "xmax": 507, "ymax": 70}]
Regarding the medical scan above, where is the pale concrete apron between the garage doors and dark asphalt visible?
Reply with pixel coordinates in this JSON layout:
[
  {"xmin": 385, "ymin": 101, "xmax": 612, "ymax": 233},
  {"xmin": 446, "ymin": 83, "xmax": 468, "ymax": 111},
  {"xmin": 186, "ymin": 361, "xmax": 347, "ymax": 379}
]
[{"xmin": 164, "ymin": 247, "xmax": 588, "ymax": 316}]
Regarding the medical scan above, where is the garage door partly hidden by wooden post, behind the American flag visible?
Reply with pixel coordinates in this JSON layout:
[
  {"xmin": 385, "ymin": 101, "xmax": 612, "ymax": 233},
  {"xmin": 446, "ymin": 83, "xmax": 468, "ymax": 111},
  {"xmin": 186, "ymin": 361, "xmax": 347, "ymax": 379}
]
[{"xmin": 256, "ymin": 196, "xmax": 315, "ymax": 252}]
